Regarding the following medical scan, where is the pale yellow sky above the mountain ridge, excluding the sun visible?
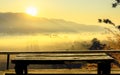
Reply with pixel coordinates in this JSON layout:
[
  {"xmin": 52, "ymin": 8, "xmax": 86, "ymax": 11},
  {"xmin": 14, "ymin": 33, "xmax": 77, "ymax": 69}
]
[{"xmin": 0, "ymin": 0, "xmax": 120, "ymax": 25}]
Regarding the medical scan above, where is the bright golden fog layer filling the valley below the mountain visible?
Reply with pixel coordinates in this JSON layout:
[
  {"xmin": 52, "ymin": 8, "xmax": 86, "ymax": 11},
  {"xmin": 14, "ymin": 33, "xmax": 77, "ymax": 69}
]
[{"xmin": 0, "ymin": 33, "xmax": 107, "ymax": 51}]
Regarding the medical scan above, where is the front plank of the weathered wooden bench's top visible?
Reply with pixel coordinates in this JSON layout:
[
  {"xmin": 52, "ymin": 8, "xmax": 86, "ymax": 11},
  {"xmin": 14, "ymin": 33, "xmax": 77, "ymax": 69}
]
[{"xmin": 14, "ymin": 56, "xmax": 113, "ymax": 60}]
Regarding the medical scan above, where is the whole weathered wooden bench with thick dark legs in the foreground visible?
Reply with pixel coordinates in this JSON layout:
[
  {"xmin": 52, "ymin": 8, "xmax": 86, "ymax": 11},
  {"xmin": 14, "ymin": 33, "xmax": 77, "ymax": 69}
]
[{"xmin": 11, "ymin": 53, "xmax": 113, "ymax": 75}]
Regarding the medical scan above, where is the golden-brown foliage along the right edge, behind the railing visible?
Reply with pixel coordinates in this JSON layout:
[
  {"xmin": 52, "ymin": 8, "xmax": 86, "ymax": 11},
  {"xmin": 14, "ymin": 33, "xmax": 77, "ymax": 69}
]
[{"xmin": 101, "ymin": 28, "xmax": 120, "ymax": 68}]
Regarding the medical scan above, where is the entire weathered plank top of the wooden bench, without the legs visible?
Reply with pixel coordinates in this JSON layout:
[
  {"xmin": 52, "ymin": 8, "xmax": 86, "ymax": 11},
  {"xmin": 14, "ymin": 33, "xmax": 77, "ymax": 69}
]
[{"xmin": 11, "ymin": 53, "xmax": 113, "ymax": 62}]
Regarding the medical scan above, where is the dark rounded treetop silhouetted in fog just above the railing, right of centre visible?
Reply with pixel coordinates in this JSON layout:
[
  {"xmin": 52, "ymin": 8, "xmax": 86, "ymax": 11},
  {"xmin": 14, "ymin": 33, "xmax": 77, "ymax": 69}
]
[{"xmin": 89, "ymin": 38, "xmax": 106, "ymax": 50}]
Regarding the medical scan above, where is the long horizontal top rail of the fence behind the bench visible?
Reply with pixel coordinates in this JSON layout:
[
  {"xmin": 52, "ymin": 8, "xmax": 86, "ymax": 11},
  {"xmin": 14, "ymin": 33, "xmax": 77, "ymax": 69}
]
[{"xmin": 0, "ymin": 50, "xmax": 120, "ymax": 54}]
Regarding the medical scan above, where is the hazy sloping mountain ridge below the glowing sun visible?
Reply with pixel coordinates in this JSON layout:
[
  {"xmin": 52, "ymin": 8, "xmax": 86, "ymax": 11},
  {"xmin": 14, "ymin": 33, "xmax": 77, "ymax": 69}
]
[{"xmin": 0, "ymin": 13, "xmax": 104, "ymax": 34}]
